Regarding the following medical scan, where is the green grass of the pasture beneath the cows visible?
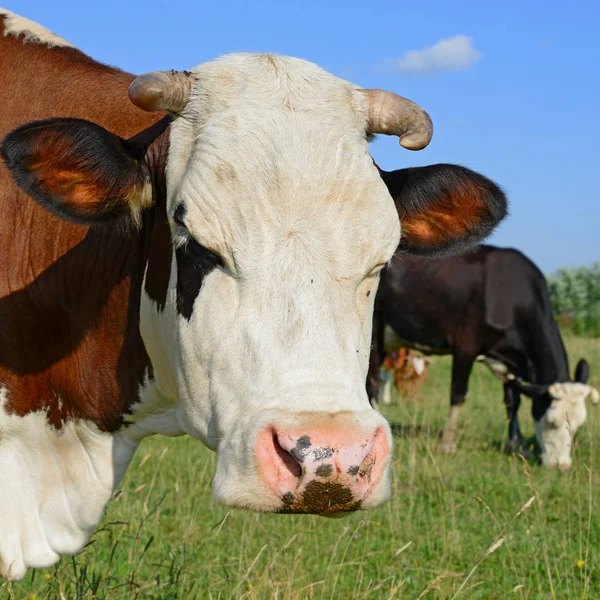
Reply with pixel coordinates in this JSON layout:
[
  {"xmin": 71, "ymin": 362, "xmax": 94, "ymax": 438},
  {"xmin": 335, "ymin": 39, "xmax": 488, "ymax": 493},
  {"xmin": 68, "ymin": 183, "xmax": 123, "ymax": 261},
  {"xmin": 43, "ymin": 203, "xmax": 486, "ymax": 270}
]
[{"xmin": 0, "ymin": 337, "xmax": 600, "ymax": 600}]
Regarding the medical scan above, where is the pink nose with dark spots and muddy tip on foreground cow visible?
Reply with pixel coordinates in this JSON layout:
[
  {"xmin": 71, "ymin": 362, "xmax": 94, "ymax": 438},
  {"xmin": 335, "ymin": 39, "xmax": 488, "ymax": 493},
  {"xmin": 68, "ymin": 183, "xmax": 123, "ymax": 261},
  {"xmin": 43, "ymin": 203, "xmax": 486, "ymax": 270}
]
[{"xmin": 256, "ymin": 426, "xmax": 389, "ymax": 514}]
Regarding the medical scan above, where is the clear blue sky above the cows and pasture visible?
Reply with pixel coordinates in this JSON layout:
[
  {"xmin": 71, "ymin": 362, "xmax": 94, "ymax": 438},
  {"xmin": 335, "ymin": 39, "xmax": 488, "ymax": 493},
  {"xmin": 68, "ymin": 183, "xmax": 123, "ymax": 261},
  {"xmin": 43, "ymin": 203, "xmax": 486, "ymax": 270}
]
[{"xmin": 5, "ymin": 0, "xmax": 600, "ymax": 272}]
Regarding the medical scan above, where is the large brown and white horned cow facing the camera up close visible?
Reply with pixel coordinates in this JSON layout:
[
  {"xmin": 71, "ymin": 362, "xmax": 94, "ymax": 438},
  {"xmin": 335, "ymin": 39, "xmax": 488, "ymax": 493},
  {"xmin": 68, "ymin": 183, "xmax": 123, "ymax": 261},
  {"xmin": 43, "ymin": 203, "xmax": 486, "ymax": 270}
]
[{"xmin": 0, "ymin": 12, "xmax": 506, "ymax": 579}]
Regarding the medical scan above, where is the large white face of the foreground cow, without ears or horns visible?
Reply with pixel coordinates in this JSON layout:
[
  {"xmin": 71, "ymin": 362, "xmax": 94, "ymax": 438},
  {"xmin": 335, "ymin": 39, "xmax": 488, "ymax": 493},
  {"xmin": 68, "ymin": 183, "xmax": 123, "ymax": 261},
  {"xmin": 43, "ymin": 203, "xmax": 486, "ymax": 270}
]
[{"xmin": 137, "ymin": 55, "xmax": 400, "ymax": 510}]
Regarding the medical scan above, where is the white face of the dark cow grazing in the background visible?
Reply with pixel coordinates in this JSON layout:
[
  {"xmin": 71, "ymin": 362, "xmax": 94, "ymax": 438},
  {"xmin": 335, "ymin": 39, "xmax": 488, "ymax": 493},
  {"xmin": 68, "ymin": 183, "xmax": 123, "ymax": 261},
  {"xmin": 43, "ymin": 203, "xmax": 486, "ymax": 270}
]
[{"xmin": 535, "ymin": 382, "xmax": 593, "ymax": 471}]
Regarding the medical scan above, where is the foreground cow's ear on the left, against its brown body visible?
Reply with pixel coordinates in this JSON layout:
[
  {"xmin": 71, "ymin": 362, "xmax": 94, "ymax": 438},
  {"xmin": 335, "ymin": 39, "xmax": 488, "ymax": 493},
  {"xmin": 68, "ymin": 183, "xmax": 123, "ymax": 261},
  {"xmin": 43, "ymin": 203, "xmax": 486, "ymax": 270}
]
[{"xmin": 2, "ymin": 119, "xmax": 152, "ymax": 224}]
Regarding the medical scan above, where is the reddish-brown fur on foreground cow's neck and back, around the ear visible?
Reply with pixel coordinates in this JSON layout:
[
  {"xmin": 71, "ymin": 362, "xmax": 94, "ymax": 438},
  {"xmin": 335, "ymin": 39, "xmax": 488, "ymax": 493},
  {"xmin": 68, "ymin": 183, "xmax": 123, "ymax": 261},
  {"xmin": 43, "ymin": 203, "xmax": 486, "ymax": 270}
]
[{"xmin": 0, "ymin": 17, "xmax": 166, "ymax": 431}]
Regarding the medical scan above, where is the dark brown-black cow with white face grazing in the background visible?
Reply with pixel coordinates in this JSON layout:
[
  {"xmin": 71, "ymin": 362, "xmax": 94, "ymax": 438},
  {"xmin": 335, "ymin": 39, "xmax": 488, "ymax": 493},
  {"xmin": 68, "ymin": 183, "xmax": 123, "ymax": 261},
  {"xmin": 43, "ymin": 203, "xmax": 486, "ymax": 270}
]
[{"xmin": 368, "ymin": 246, "xmax": 596, "ymax": 468}]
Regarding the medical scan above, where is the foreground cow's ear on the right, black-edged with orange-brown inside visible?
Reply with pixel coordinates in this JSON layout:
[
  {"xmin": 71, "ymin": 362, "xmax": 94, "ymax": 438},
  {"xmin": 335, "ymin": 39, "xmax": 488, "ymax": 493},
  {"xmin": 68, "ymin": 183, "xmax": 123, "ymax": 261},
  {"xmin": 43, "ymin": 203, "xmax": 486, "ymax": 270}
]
[{"xmin": 381, "ymin": 164, "xmax": 507, "ymax": 256}]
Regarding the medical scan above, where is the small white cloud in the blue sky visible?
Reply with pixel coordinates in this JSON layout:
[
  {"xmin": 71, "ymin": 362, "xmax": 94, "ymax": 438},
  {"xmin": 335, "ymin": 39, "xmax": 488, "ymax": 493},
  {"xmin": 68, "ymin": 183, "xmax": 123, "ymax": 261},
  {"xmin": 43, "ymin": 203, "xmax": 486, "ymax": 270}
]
[{"xmin": 388, "ymin": 35, "xmax": 481, "ymax": 73}]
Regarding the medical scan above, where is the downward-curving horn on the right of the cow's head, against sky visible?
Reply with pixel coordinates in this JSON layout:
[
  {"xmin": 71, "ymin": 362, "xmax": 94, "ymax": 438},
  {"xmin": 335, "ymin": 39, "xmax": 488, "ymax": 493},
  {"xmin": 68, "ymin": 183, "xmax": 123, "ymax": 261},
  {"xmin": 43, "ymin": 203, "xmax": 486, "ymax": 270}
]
[{"xmin": 360, "ymin": 90, "xmax": 433, "ymax": 150}]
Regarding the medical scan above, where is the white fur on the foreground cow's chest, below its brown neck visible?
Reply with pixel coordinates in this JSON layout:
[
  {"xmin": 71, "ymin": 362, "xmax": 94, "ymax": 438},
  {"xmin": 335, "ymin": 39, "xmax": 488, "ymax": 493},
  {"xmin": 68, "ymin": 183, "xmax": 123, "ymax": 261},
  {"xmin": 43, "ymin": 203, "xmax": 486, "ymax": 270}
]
[{"xmin": 0, "ymin": 387, "xmax": 137, "ymax": 579}]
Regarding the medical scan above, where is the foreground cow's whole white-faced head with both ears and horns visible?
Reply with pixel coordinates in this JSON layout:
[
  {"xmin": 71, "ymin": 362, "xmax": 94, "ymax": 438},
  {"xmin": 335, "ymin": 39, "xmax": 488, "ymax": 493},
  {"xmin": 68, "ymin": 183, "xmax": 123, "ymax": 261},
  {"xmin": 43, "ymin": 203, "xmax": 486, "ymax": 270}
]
[{"xmin": 4, "ymin": 55, "xmax": 505, "ymax": 514}]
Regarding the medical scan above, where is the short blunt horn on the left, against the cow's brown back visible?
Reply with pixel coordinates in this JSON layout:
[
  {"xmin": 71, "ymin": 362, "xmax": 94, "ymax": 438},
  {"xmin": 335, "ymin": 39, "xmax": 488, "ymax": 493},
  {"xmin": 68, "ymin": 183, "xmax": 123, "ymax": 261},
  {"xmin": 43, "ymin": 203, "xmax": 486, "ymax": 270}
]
[{"xmin": 129, "ymin": 71, "xmax": 195, "ymax": 114}]
